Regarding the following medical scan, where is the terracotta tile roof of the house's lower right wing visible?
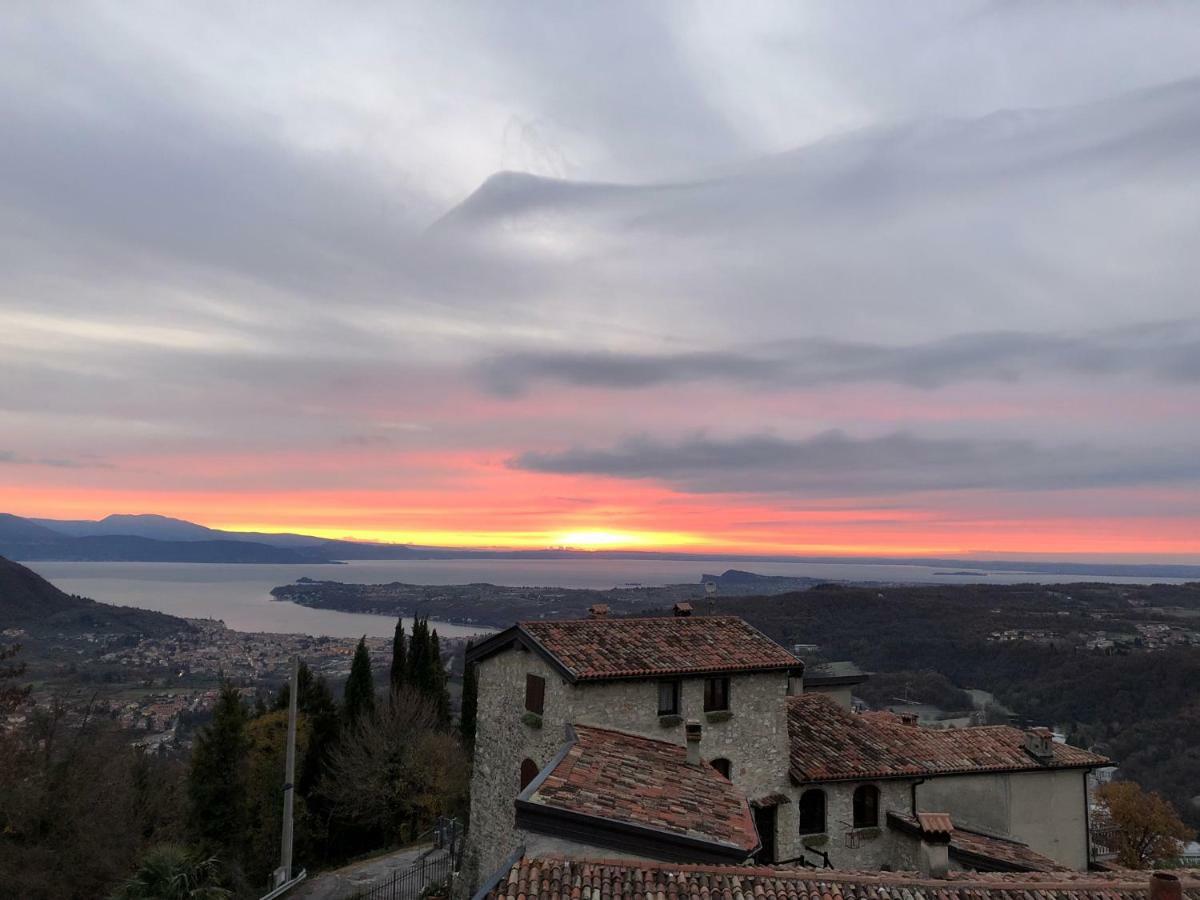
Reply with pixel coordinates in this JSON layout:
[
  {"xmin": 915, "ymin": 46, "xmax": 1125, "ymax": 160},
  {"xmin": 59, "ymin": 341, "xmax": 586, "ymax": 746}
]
[{"xmin": 787, "ymin": 694, "xmax": 1109, "ymax": 782}]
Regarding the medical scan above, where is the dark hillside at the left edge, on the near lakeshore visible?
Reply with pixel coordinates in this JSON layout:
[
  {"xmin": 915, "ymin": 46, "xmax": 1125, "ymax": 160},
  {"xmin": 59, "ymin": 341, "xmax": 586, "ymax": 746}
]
[{"xmin": 0, "ymin": 557, "xmax": 192, "ymax": 636}]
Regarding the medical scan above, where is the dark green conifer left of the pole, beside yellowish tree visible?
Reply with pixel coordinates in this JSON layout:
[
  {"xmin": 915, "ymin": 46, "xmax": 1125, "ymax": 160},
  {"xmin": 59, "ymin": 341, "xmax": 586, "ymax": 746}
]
[{"xmin": 187, "ymin": 682, "xmax": 250, "ymax": 860}]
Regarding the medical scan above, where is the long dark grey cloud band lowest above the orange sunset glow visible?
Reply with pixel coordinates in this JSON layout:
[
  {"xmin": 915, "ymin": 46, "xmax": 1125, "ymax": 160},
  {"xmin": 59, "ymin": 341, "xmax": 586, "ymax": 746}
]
[{"xmin": 509, "ymin": 431, "xmax": 1200, "ymax": 496}]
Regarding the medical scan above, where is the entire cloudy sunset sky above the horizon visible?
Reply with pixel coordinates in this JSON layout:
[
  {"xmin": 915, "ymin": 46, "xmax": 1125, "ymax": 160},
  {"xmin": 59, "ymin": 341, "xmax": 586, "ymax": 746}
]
[{"xmin": 0, "ymin": 1, "xmax": 1200, "ymax": 562}]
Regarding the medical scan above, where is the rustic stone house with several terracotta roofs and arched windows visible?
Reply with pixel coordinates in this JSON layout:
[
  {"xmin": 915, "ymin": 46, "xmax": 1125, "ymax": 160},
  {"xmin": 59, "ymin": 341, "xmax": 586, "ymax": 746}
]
[{"xmin": 468, "ymin": 608, "xmax": 1108, "ymax": 880}]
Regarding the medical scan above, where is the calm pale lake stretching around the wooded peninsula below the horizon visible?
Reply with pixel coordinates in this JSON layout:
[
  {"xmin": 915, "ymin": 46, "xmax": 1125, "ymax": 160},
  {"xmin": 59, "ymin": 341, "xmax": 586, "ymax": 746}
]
[{"xmin": 18, "ymin": 559, "xmax": 1182, "ymax": 637}]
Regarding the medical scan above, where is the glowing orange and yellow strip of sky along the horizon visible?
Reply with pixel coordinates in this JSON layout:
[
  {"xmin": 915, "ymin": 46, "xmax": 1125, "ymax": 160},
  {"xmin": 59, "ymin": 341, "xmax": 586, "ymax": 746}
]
[{"xmin": 0, "ymin": 480, "xmax": 1200, "ymax": 562}]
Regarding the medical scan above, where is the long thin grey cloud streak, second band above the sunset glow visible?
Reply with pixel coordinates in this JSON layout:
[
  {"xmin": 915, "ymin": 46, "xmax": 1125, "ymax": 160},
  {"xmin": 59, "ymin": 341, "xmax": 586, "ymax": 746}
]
[{"xmin": 475, "ymin": 322, "xmax": 1200, "ymax": 395}]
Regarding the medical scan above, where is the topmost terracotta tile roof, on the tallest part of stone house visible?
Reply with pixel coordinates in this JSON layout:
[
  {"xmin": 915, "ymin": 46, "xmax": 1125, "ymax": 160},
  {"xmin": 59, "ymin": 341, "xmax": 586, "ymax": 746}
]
[{"xmin": 517, "ymin": 616, "xmax": 804, "ymax": 680}]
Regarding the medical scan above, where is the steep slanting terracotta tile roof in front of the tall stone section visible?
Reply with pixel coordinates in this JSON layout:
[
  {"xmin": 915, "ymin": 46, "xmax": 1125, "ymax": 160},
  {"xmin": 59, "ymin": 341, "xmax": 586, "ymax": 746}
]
[{"xmin": 522, "ymin": 725, "xmax": 758, "ymax": 857}]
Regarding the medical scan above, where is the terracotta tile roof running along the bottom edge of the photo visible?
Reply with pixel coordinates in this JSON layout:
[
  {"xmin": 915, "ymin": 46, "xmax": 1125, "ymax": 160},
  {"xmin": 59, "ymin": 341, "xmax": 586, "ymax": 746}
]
[{"xmin": 486, "ymin": 857, "xmax": 1200, "ymax": 900}]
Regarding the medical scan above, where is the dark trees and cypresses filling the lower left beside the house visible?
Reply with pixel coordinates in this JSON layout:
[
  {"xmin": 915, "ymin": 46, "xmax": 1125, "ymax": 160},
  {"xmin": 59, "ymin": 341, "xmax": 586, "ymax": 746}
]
[{"xmin": 0, "ymin": 619, "xmax": 487, "ymax": 900}]
